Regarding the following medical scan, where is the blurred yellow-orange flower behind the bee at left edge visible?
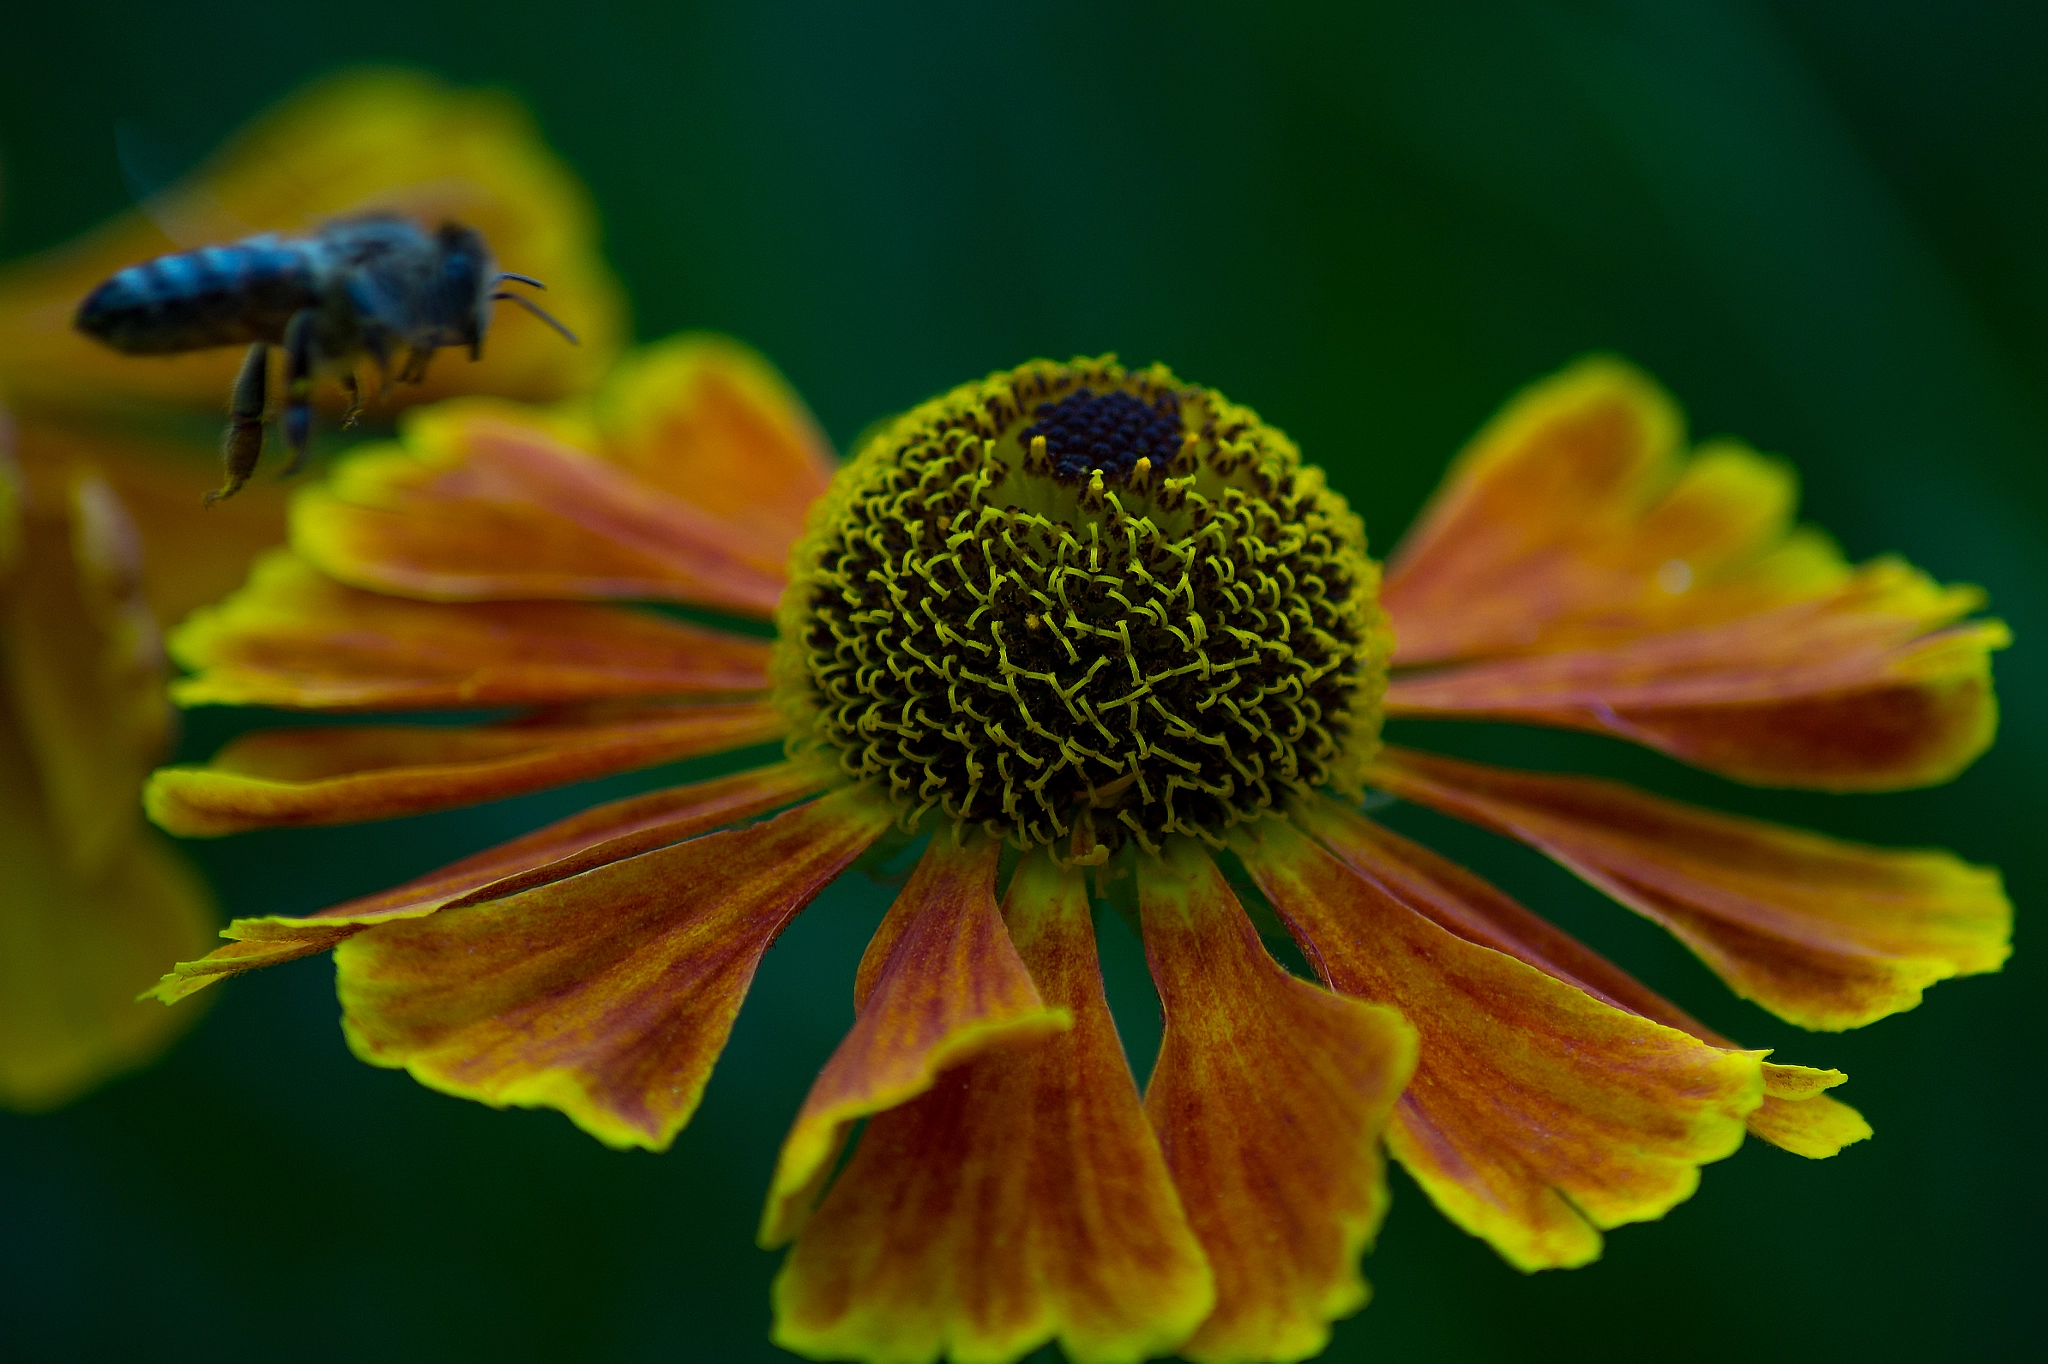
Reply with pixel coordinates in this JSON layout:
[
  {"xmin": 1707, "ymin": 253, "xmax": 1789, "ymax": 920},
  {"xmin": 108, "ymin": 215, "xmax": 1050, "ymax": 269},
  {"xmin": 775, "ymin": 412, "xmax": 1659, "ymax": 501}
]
[{"xmin": 0, "ymin": 72, "xmax": 625, "ymax": 1108}]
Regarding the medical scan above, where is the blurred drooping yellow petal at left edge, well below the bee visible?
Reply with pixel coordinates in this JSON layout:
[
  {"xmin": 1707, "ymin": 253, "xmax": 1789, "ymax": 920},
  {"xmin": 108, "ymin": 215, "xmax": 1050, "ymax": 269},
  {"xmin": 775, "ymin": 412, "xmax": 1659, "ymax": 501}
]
[{"xmin": 0, "ymin": 414, "xmax": 213, "ymax": 1108}]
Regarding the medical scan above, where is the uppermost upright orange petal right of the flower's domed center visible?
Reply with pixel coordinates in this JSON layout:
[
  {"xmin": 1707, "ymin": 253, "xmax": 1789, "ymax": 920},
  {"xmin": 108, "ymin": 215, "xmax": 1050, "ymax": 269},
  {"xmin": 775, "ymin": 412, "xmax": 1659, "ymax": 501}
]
[{"xmin": 1380, "ymin": 356, "xmax": 1849, "ymax": 666}]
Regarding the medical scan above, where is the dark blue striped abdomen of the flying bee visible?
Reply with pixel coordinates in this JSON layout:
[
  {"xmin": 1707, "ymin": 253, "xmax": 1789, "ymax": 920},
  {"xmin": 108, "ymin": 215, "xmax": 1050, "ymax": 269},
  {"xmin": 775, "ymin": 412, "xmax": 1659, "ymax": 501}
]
[{"xmin": 76, "ymin": 238, "xmax": 317, "ymax": 354}]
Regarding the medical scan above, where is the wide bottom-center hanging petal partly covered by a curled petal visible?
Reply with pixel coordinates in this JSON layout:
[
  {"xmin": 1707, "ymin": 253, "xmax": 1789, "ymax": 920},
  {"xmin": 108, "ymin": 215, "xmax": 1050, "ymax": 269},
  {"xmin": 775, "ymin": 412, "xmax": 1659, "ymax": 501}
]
[{"xmin": 774, "ymin": 854, "xmax": 1214, "ymax": 1364}]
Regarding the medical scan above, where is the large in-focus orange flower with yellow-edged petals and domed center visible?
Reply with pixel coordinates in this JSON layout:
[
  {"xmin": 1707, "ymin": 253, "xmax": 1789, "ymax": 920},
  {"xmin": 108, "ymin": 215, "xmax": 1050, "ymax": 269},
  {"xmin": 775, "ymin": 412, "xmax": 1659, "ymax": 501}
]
[{"xmin": 147, "ymin": 338, "xmax": 2009, "ymax": 1360}]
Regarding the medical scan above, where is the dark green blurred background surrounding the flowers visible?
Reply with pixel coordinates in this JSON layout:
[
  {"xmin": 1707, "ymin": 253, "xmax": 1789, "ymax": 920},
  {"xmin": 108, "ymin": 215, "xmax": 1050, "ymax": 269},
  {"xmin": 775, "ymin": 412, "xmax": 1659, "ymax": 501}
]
[{"xmin": 0, "ymin": 0, "xmax": 2048, "ymax": 1360}]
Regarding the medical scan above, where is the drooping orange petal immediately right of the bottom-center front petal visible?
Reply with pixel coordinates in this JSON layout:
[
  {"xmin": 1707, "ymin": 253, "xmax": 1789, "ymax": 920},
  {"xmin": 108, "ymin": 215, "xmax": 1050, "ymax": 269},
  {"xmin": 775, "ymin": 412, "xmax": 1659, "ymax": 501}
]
[{"xmin": 1137, "ymin": 840, "xmax": 1415, "ymax": 1364}]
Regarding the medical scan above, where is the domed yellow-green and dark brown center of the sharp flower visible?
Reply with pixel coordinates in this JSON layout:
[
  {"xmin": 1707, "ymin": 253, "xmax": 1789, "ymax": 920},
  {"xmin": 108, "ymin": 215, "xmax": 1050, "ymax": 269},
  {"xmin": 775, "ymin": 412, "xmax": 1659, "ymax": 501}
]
[{"xmin": 776, "ymin": 358, "xmax": 1393, "ymax": 848}]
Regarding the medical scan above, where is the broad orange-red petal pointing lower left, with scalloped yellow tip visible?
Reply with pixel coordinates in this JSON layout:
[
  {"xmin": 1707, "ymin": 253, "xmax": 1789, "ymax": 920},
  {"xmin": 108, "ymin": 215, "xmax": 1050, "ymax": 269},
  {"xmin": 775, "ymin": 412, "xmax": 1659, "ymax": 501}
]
[{"xmin": 334, "ymin": 793, "xmax": 887, "ymax": 1151}]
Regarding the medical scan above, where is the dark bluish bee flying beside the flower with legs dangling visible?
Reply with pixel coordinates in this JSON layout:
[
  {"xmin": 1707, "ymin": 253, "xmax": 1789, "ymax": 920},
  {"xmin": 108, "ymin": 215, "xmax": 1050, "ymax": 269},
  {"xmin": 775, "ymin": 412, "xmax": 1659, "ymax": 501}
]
[{"xmin": 74, "ymin": 213, "xmax": 575, "ymax": 506}]
